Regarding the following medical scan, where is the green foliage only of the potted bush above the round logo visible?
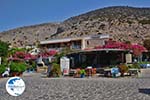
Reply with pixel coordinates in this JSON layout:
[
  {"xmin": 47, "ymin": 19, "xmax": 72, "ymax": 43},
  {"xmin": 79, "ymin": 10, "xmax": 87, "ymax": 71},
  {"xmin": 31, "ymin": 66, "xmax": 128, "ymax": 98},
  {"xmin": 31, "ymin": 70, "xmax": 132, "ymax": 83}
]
[{"xmin": 10, "ymin": 62, "xmax": 26, "ymax": 72}]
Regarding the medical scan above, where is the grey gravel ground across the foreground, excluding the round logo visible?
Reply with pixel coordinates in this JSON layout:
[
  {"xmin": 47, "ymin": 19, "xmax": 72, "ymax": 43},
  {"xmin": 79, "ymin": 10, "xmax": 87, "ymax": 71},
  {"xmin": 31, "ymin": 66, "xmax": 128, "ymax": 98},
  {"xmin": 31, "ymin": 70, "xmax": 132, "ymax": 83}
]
[{"xmin": 0, "ymin": 74, "xmax": 150, "ymax": 100}]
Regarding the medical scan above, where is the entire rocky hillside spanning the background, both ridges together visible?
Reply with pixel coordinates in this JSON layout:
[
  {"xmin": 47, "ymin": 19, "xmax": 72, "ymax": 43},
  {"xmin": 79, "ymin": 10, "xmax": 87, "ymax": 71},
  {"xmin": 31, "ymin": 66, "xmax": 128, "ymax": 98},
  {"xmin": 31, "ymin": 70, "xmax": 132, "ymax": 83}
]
[{"xmin": 0, "ymin": 6, "xmax": 150, "ymax": 46}]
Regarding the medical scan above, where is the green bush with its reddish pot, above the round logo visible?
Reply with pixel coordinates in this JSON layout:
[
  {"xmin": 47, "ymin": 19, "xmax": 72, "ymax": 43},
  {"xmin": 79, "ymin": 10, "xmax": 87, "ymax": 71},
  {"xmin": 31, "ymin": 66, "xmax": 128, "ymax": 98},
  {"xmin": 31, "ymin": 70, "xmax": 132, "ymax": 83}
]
[{"xmin": 10, "ymin": 62, "xmax": 26, "ymax": 76}]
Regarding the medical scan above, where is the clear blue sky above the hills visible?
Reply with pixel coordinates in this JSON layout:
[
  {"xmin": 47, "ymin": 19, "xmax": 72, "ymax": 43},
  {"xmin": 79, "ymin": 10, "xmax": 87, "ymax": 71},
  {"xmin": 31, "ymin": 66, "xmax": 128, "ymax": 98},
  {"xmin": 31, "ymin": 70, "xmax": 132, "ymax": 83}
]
[{"xmin": 0, "ymin": 0, "xmax": 150, "ymax": 32}]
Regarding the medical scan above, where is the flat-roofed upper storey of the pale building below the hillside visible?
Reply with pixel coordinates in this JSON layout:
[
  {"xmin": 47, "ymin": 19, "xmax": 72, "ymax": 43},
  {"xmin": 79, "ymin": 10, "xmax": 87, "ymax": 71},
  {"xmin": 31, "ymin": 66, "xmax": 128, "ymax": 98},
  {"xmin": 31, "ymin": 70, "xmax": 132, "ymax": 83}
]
[{"xmin": 40, "ymin": 34, "xmax": 110, "ymax": 50}]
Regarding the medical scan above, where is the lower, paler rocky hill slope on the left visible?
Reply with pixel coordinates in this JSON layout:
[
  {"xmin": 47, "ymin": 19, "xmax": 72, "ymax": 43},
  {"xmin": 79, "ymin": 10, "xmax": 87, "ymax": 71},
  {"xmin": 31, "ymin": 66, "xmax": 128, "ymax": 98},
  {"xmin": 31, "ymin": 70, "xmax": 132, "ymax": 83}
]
[{"xmin": 0, "ymin": 23, "xmax": 59, "ymax": 47}]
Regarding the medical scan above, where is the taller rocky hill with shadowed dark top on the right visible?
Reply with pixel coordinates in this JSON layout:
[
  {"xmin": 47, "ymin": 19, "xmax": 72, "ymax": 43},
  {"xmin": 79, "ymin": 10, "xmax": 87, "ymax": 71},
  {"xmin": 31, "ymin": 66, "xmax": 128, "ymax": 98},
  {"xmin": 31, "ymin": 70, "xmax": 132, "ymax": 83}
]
[{"xmin": 59, "ymin": 7, "xmax": 150, "ymax": 43}]
